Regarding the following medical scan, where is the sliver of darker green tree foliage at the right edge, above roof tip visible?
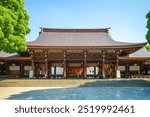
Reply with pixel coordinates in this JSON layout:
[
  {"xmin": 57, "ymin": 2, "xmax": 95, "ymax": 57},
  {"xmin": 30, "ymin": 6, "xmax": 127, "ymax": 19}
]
[{"xmin": 146, "ymin": 11, "xmax": 150, "ymax": 44}]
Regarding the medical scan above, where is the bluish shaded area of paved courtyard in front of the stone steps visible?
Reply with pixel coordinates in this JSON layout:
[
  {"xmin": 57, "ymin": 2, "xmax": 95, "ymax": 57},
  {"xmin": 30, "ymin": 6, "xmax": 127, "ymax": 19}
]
[{"xmin": 7, "ymin": 87, "xmax": 150, "ymax": 100}]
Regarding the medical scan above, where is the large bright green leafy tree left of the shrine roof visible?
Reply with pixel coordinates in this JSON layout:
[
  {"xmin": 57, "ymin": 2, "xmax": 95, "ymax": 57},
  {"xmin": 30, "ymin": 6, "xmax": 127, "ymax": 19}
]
[{"xmin": 0, "ymin": 0, "xmax": 30, "ymax": 53}]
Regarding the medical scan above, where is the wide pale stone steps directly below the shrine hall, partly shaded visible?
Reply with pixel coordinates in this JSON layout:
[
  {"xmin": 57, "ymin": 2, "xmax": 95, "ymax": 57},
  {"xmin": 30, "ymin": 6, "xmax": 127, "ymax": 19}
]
[{"xmin": 0, "ymin": 78, "xmax": 150, "ymax": 87}]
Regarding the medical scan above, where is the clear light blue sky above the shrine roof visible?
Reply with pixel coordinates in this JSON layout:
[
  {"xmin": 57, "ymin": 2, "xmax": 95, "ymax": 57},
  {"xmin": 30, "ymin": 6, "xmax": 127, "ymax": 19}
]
[{"xmin": 25, "ymin": 0, "xmax": 150, "ymax": 42}]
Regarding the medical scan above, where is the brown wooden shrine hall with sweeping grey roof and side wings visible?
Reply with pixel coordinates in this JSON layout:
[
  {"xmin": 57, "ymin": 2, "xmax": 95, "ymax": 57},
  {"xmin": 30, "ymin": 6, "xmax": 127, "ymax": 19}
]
[{"xmin": 0, "ymin": 28, "xmax": 150, "ymax": 79}]
